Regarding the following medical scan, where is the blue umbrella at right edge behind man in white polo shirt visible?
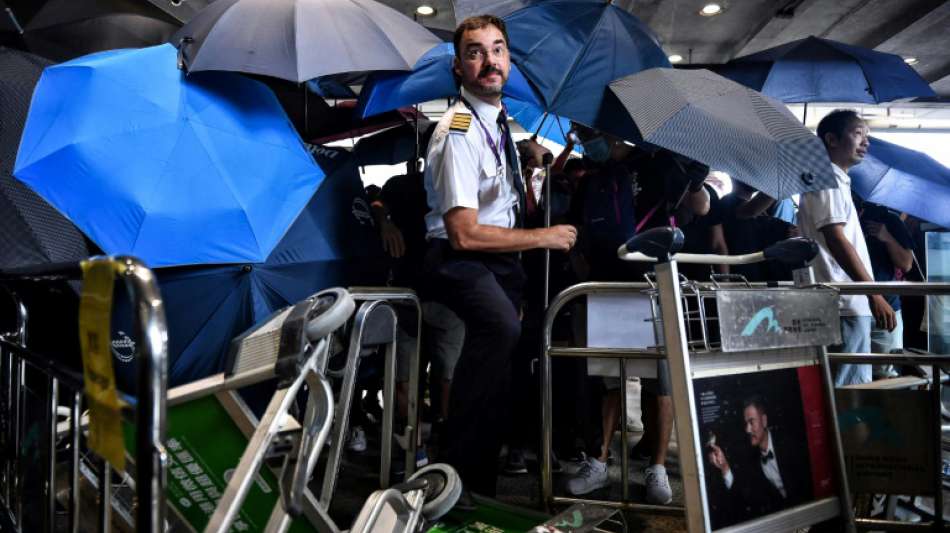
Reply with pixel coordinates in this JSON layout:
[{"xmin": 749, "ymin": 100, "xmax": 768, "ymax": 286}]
[{"xmin": 848, "ymin": 137, "xmax": 950, "ymax": 228}]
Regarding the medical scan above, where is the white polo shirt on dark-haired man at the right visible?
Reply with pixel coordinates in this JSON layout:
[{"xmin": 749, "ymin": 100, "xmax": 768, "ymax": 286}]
[{"xmin": 798, "ymin": 163, "xmax": 873, "ymax": 316}]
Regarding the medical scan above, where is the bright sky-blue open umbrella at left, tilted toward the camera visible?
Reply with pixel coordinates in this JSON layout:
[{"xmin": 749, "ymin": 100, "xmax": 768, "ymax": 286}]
[{"xmin": 14, "ymin": 44, "xmax": 323, "ymax": 267}]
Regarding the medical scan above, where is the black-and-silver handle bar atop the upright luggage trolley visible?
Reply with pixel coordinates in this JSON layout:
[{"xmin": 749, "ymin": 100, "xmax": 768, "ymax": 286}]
[{"xmin": 617, "ymin": 226, "xmax": 818, "ymax": 269}]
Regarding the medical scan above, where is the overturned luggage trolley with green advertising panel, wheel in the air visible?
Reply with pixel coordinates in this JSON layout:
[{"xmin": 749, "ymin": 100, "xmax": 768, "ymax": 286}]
[{"xmin": 157, "ymin": 287, "xmax": 432, "ymax": 531}]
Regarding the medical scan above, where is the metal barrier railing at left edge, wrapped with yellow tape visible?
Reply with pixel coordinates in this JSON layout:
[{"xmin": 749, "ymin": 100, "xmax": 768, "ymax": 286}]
[{"xmin": 0, "ymin": 257, "xmax": 168, "ymax": 533}]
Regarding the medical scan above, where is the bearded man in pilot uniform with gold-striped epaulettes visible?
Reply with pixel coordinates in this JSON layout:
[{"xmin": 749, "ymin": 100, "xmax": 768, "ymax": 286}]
[{"xmin": 424, "ymin": 15, "xmax": 577, "ymax": 496}]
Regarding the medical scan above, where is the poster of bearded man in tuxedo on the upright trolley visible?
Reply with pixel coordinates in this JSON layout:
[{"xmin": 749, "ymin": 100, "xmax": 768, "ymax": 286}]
[{"xmin": 694, "ymin": 367, "xmax": 833, "ymax": 529}]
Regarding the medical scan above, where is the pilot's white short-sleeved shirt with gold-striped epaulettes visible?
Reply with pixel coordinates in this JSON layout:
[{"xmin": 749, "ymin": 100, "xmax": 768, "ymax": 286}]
[{"xmin": 425, "ymin": 88, "xmax": 519, "ymax": 239}]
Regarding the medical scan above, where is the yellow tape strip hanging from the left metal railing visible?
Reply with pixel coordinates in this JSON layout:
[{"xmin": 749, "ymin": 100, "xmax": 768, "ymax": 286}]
[{"xmin": 79, "ymin": 259, "xmax": 125, "ymax": 471}]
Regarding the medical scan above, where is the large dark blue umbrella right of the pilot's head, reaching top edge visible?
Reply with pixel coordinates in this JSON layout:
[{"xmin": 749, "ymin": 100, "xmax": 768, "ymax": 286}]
[{"xmin": 504, "ymin": 0, "xmax": 670, "ymax": 127}]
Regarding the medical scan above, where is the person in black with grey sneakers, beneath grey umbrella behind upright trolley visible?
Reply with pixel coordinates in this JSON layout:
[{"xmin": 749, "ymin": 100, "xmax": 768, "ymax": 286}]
[{"xmin": 567, "ymin": 125, "xmax": 709, "ymax": 505}]
